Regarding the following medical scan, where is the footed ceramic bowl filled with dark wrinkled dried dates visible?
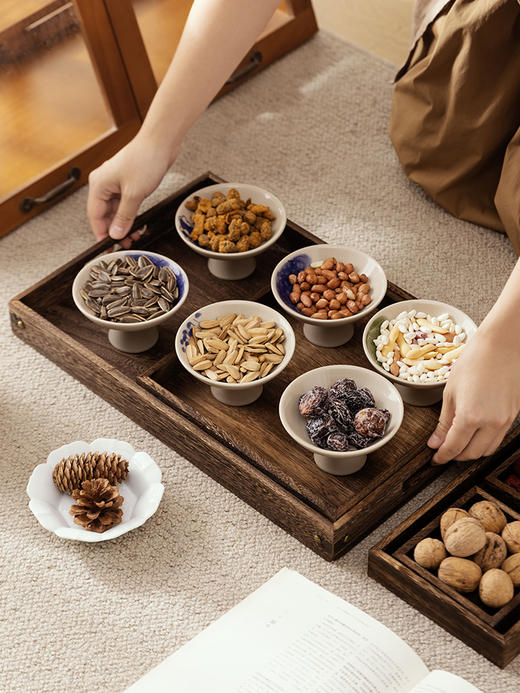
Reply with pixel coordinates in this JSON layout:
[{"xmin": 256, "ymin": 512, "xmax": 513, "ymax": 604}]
[{"xmin": 279, "ymin": 365, "xmax": 404, "ymax": 476}]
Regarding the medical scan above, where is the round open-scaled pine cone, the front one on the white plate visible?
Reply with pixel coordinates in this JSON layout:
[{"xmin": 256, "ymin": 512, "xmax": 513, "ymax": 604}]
[{"xmin": 69, "ymin": 479, "xmax": 124, "ymax": 532}]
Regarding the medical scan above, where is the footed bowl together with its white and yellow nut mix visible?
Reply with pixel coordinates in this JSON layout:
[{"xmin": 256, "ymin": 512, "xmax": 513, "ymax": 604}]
[{"xmin": 363, "ymin": 299, "xmax": 477, "ymax": 406}]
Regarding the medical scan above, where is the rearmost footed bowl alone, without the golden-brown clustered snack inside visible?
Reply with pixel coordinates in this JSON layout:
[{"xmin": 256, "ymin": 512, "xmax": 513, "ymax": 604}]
[{"xmin": 175, "ymin": 183, "xmax": 287, "ymax": 280}]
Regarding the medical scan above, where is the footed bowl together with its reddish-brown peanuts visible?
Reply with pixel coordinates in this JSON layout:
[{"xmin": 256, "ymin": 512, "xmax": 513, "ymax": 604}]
[{"xmin": 271, "ymin": 244, "xmax": 387, "ymax": 347}]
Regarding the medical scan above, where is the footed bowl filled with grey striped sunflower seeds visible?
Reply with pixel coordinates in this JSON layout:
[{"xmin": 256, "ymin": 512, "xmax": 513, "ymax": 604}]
[{"xmin": 72, "ymin": 250, "xmax": 189, "ymax": 354}]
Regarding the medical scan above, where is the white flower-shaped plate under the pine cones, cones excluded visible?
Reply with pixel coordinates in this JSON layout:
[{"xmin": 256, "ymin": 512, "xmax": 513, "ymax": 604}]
[{"xmin": 27, "ymin": 438, "xmax": 164, "ymax": 542}]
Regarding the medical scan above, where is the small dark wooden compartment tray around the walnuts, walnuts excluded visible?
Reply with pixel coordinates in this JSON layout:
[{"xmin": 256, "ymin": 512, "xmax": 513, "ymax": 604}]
[{"xmin": 368, "ymin": 442, "xmax": 520, "ymax": 667}]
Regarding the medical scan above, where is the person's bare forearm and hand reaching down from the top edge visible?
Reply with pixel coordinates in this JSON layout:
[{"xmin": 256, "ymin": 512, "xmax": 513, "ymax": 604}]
[{"xmin": 87, "ymin": 0, "xmax": 279, "ymax": 244}]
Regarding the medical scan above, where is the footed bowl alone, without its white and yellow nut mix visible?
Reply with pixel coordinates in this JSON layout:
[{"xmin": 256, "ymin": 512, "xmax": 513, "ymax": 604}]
[{"xmin": 362, "ymin": 299, "xmax": 477, "ymax": 406}]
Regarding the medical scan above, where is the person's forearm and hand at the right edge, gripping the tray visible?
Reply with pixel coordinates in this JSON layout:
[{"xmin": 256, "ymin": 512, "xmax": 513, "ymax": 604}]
[{"xmin": 428, "ymin": 260, "xmax": 520, "ymax": 464}]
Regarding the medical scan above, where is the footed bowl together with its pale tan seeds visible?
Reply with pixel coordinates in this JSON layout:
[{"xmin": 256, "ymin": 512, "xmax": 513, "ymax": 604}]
[{"xmin": 175, "ymin": 301, "xmax": 295, "ymax": 406}]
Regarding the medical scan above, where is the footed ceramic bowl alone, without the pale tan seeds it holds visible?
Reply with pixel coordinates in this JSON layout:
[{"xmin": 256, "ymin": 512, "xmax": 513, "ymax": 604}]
[{"xmin": 175, "ymin": 301, "xmax": 295, "ymax": 406}]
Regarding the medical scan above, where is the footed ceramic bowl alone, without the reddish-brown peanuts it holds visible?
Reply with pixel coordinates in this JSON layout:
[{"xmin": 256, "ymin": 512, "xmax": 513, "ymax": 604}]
[{"xmin": 271, "ymin": 244, "xmax": 387, "ymax": 347}]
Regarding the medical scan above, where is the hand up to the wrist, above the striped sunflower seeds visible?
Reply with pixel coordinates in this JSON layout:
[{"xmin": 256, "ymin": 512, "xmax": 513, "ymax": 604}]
[{"xmin": 87, "ymin": 135, "xmax": 176, "ymax": 248}]
